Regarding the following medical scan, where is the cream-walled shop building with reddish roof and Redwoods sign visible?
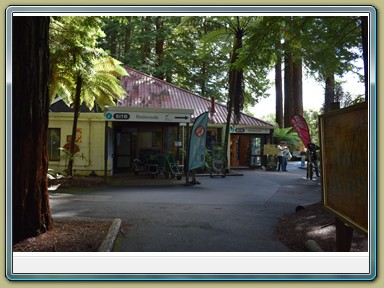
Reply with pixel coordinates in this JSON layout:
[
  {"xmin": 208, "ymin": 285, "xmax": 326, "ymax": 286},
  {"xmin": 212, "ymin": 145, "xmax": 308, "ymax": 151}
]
[{"xmin": 48, "ymin": 68, "xmax": 274, "ymax": 175}]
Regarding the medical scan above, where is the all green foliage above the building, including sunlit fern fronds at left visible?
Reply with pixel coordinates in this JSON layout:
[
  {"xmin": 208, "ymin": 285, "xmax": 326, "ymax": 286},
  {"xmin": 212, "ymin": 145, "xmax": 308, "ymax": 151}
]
[{"xmin": 46, "ymin": 16, "xmax": 362, "ymax": 174}]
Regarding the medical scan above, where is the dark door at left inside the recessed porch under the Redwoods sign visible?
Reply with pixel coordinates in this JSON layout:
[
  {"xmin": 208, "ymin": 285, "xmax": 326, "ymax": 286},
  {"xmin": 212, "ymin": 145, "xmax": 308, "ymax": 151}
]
[{"xmin": 113, "ymin": 132, "xmax": 132, "ymax": 172}]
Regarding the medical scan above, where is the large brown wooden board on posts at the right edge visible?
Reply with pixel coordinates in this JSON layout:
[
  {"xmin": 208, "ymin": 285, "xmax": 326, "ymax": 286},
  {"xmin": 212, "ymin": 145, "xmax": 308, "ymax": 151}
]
[{"xmin": 319, "ymin": 102, "xmax": 369, "ymax": 233}]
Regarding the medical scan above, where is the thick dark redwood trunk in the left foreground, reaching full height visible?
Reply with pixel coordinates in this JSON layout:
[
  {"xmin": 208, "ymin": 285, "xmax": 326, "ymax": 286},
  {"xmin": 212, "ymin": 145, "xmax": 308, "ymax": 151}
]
[{"xmin": 12, "ymin": 16, "xmax": 53, "ymax": 244}]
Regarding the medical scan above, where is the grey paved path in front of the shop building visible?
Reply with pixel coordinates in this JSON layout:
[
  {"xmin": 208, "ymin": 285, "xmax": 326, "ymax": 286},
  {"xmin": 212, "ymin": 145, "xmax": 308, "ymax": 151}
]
[{"xmin": 50, "ymin": 162, "xmax": 321, "ymax": 252}]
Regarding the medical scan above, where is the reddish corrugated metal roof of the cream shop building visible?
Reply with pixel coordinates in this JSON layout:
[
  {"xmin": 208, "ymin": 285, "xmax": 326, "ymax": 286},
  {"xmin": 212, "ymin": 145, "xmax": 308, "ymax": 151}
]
[{"xmin": 118, "ymin": 67, "xmax": 273, "ymax": 128}]
